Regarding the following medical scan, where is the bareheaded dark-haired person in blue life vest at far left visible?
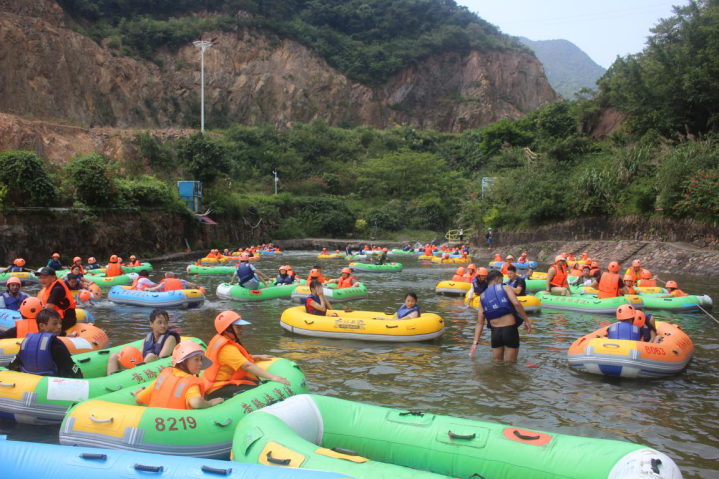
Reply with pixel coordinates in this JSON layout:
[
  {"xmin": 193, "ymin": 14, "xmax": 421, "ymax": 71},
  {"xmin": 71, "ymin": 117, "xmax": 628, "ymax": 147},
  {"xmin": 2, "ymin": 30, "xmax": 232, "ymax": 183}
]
[{"xmin": 8, "ymin": 309, "xmax": 83, "ymax": 379}]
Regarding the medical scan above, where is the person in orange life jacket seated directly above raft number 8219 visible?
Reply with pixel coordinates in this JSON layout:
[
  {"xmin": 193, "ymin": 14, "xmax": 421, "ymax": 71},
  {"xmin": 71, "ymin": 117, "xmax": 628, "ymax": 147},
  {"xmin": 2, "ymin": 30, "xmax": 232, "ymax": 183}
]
[{"xmin": 132, "ymin": 340, "xmax": 224, "ymax": 409}]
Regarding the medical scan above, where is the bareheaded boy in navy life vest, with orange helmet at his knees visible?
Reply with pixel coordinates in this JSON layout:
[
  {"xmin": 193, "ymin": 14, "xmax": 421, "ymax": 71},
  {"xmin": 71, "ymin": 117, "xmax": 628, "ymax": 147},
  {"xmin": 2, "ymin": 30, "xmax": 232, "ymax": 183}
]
[{"xmin": 107, "ymin": 308, "xmax": 180, "ymax": 376}]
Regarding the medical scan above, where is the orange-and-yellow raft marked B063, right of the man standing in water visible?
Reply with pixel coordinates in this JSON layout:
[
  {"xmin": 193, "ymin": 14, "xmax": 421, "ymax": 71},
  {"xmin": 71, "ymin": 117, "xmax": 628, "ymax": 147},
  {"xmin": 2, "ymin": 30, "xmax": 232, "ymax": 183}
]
[{"xmin": 567, "ymin": 321, "xmax": 694, "ymax": 378}]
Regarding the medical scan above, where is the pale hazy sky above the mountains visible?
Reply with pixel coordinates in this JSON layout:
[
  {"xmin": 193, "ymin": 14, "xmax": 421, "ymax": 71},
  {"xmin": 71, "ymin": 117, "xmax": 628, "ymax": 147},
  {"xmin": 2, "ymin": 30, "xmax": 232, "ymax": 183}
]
[{"xmin": 457, "ymin": 0, "xmax": 689, "ymax": 68}]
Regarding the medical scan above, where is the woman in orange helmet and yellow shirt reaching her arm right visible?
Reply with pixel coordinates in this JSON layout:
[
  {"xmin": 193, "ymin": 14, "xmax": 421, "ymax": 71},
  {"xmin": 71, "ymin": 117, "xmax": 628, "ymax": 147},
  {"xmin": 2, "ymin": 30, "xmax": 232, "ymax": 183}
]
[{"xmin": 202, "ymin": 311, "xmax": 290, "ymax": 399}]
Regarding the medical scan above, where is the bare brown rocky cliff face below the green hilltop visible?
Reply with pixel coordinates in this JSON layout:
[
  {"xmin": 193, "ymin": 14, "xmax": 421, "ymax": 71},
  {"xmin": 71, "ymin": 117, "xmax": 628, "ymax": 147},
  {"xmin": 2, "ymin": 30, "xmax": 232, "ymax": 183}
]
[{"xmin": 0, "ymin": 0, "xmax": 557, "ymax": 135}]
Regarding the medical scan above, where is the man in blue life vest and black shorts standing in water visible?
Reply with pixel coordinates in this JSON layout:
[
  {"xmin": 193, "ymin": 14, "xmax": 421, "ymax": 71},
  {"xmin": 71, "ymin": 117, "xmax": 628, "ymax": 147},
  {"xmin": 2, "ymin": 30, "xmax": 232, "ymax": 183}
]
[{"xmin": 469, "ymin": 271, "xmax": 532, "ymax": 362}]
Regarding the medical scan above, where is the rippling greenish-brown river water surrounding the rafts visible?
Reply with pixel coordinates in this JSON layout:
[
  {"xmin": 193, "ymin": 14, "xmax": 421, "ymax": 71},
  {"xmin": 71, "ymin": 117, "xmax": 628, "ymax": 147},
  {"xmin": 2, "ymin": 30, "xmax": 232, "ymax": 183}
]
[{"xmin": 0, "ymin": 252, "xmax": 719, "ymax": 478}]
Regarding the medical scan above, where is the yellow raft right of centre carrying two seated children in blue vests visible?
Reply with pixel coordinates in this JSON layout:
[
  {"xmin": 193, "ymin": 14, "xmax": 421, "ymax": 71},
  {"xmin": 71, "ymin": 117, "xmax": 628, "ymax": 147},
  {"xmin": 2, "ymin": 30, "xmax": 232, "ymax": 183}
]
[{"xmin": 280, "ymin": 306, "xmax": 444, "ymax": 342}]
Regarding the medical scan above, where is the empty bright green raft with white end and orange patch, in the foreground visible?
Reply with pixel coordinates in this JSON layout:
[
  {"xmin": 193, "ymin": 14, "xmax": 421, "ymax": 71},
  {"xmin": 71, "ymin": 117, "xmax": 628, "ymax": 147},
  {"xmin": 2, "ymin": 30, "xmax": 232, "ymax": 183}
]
[{"xmin": 232, "ymin": 394, "xmax": 682, "ymax": 479}]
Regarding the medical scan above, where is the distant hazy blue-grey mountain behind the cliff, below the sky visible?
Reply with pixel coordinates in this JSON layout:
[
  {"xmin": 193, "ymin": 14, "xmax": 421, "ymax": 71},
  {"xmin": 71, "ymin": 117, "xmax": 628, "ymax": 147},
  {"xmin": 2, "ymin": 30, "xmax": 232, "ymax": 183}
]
[{"xmin": 519, "ymin": 37, "xmax": 606, "ymax": 98}]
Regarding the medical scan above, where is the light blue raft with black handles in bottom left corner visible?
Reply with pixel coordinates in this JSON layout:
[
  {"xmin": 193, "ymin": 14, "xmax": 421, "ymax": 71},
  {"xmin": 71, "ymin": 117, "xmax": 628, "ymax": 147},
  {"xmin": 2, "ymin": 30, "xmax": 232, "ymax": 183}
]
[{"xmin": 0, "ymin": 436, "xmax": 350, "ymax": 479}]
